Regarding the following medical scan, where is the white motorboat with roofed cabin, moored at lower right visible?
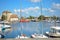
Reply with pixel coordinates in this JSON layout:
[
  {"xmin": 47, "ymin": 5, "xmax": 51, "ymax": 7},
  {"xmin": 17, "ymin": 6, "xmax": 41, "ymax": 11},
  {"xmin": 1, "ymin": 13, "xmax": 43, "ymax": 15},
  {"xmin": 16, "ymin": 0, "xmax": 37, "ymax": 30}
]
[{"xmin": 46, "ymin": 26, "xmax": 60, "ymax": 38}]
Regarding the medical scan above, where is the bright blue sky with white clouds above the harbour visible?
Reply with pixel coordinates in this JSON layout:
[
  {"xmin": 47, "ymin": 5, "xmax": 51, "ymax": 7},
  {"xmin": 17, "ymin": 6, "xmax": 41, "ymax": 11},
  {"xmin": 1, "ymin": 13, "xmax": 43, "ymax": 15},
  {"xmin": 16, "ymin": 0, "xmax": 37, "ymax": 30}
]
[{"xmin": 0, "ymin": 0, "xmax": 60, "ymax": 17}]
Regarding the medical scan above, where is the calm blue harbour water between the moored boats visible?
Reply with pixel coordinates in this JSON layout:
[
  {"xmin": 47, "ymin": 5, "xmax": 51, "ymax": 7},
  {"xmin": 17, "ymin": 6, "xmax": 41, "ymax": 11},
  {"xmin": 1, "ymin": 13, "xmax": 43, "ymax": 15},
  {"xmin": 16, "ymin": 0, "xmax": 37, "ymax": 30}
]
[{"xmin": 4, "ymin": 21, "xmax": 60, "ymax": 38}]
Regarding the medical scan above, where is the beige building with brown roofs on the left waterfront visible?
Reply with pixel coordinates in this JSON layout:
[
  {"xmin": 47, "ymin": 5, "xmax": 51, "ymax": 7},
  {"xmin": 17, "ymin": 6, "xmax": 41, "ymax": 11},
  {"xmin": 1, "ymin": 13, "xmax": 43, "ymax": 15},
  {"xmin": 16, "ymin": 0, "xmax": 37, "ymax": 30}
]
[{"xmin": 2, "ymin": 11, "xmax": 18, "ymax": 21}]
